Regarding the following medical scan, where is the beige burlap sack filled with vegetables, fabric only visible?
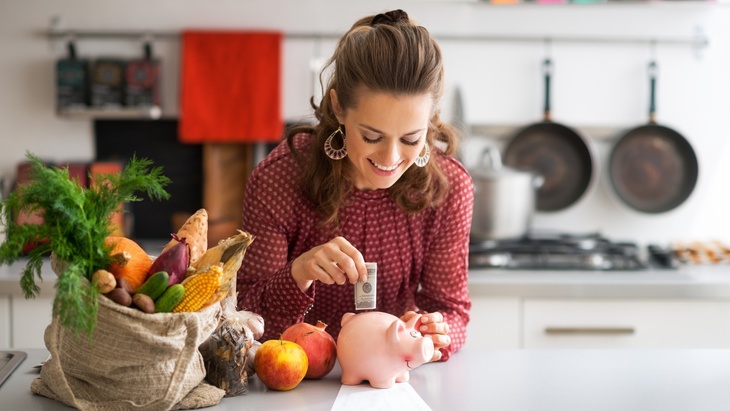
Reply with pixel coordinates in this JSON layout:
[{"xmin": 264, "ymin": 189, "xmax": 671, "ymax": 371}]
[{"xmin": 31, "ymin": 296, "xmax": 225, "ymax": 411}]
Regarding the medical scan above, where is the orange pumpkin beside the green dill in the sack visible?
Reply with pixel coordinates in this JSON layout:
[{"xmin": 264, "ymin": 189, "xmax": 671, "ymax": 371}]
[{"xmin": 106, "ymin": 236, "xmax": 152, "ymax": 290}]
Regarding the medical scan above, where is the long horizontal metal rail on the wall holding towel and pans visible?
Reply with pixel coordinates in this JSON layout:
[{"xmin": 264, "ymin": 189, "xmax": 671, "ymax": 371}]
[{"xmin": 45, "ymin": 29, "xmax": 709, "ymax": 51}]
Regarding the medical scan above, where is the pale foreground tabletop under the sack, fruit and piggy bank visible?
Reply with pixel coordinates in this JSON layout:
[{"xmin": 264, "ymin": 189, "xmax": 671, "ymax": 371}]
[{"xmin": 0, "ymin": 349, "xmax": 730, "ymax": 411}]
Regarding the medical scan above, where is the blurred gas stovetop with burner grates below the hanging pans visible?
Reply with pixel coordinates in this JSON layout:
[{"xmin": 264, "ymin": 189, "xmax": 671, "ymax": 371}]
[{"xmin": 469, "ymin": 232, "xmax": 678, "ymax": 271}]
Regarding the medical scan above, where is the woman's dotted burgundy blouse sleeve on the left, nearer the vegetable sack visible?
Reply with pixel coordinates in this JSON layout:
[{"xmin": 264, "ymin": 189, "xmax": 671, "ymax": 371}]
[{"xmin": 237, "ymin": 158, "xmax": 314, "ymax": 341}]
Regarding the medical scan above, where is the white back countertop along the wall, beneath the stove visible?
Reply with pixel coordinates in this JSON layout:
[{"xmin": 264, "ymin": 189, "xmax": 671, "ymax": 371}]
[{"xmin": 0, "ymin": 260, "xmax": 730, "ymax": 299}]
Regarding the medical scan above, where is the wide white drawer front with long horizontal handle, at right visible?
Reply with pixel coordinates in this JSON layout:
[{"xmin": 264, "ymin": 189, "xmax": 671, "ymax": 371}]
[{"xmin": 523, "ymin": 300, "xmax": 730, "ymax": 348}]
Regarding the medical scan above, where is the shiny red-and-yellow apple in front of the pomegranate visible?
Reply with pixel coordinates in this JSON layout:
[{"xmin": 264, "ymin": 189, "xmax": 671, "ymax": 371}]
[{"xmin": 253, "ymin": 339, "xmax": 309, "ymax": 391}]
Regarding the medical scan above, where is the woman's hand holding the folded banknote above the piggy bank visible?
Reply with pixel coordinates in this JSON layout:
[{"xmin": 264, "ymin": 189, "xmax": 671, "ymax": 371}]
[{"xmin": 291, "ymin": 237, "xmax": 367, "ymax": 292}]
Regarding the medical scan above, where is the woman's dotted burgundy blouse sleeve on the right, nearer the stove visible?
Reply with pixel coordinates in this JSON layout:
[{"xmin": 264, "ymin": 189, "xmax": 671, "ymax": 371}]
[{"xmin": 416, "ymin": 159, "xmax": 474, "ymax": 361}]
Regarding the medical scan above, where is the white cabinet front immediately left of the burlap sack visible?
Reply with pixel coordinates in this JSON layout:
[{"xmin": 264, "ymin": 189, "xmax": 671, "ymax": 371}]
[{"xmin": 11, "ymin": 297, "xmax": 53, "ymax": 348}]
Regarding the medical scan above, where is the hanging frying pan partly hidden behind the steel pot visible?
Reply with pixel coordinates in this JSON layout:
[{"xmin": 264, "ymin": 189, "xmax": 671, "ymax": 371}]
[{"xmin": 503, "ymin": 59, "xmax": 596, "ymax": 211}]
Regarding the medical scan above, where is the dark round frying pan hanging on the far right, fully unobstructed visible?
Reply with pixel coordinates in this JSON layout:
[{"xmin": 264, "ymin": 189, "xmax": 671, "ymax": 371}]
[{"xmin": 608, "ymin": 61, "xmax": 699, "ymax": 213}]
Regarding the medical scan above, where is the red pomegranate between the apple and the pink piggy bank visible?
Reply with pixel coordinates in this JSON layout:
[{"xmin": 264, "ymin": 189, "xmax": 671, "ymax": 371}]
[{"xmin": 281, "ymin": 321, "xmax": 337, "ymax": 380}]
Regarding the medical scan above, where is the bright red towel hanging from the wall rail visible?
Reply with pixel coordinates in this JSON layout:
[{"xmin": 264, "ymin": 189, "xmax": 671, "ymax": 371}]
[{"xmin": 179, "ymin": 30, "xmax": 284, "ymax": 143}]
